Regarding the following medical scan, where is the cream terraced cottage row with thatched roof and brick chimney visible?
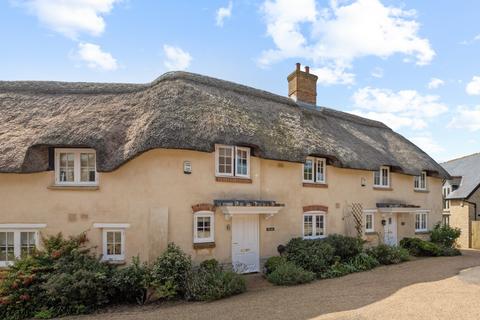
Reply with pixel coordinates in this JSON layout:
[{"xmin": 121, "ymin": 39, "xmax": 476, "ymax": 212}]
[{"xmin": 0, "ymin": 64, "xmax": 449, "ymax": 272}]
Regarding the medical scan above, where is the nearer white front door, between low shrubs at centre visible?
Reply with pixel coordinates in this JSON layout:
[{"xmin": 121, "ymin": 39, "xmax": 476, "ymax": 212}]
[{"xmin": 232, "ymin": 214, "xmax": 260, "ymax": 273}]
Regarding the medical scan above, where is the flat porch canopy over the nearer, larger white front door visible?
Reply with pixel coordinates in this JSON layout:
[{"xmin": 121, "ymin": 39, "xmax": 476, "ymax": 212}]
[{"xmin": 213, "ymin": 199, "xmax": 285, "ymax": 219}]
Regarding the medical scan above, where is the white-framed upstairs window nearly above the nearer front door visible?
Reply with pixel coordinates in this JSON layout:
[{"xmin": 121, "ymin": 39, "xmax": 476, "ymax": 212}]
[{"xmin": 215, "ymin": 145, "xmax": 250, "ymax": 178}]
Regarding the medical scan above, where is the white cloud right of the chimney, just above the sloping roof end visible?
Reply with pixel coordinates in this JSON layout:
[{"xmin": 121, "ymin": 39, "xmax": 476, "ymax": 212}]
[{"xmin": 352, "ymin": 87, "xmax": 448, "ymax": 130}]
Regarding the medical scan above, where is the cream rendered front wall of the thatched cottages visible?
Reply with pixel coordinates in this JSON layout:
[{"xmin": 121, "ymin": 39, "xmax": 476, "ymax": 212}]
[{"xmin": 0, "ymin": 149, "xmax": 442, "ymax": 262}]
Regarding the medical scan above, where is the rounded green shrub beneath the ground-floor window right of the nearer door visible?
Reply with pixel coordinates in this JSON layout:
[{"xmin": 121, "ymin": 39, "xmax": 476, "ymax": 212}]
[{"xmin": 285, "ymin": 238, "xmax": 335, "ymax": 274}]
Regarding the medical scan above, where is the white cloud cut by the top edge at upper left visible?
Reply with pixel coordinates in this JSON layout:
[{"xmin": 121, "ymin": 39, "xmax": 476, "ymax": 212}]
[{"xmin": 14, "ymin": 0, "xmax": 119, "ymax": 38}]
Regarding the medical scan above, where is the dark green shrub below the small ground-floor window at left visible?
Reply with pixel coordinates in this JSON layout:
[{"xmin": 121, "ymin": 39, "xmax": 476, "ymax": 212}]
[{"xmin": 110, "ymin": 257, "xmax": 152, "ymax": 304}]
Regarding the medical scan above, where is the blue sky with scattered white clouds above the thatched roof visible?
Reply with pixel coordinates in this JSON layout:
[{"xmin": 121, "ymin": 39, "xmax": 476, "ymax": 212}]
[{"xmin": 0, "ymin": 0, "xmax": 480, "ymax": 161}]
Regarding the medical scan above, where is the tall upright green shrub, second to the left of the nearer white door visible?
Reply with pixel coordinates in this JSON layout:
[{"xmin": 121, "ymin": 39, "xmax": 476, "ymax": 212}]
[{"xmin": 152, "ymin": 243, "xmax": 192, "ymax": 298}]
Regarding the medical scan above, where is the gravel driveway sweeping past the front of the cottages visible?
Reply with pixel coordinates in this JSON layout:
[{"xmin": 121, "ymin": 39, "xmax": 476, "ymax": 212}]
[{"xmin": 68, "ymin": 251, "xmax": 480, "ymax": 320}]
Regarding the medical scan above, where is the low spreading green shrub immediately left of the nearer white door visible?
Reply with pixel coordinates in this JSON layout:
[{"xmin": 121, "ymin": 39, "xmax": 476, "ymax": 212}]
[{"xmin": 185, "ymin": 259, "xmax": 246, "ymax": 301}]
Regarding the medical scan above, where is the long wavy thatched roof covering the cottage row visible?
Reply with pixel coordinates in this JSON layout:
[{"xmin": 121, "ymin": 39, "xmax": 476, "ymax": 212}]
[{"xmin": 0, "ymin": 72, "xmax": 448, "ymax": 177}]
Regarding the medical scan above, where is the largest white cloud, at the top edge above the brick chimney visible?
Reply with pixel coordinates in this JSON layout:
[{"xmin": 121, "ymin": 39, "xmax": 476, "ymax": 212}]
[{"xmin": 258, "ymin": 0, "xmax": 435, "ymax": 84}]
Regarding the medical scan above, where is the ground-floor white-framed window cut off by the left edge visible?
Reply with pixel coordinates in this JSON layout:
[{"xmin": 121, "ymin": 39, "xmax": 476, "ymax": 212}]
[{"xmin": 0, "ymin": 229, "xmax": 39, "ymax": 267}]
